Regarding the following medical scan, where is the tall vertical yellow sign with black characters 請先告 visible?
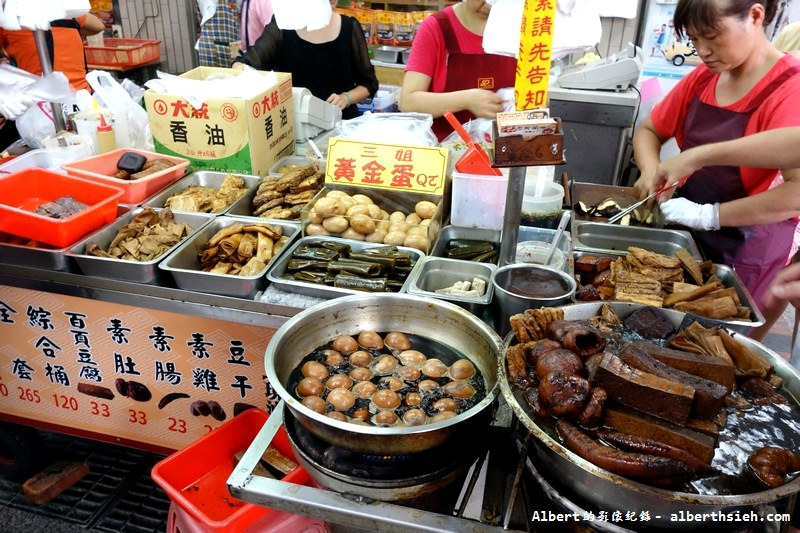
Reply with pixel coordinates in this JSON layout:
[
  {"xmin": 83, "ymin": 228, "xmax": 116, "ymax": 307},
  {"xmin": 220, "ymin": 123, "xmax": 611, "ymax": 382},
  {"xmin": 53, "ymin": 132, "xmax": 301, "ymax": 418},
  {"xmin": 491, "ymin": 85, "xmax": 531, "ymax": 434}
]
[{"xmin": 514, "ymin": 0, "xmax": 556, "ymax": 111}]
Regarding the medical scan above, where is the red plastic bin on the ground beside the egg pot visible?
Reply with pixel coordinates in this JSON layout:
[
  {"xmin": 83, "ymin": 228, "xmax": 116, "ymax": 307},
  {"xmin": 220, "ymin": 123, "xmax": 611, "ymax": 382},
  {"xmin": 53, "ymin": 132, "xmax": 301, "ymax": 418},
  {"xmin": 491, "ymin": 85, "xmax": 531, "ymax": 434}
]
[{"xmin": 150, "ymin": 409, "xmax": 311, "ymax": 533}]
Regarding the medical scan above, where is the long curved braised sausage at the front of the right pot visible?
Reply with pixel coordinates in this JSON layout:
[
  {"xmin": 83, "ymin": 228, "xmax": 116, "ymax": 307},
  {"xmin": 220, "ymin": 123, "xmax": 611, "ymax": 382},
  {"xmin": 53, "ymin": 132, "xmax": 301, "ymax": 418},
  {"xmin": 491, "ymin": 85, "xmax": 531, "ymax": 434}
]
[{"xmin": 556, "ymin": 420, "xmax": 694, "ymax": 479}]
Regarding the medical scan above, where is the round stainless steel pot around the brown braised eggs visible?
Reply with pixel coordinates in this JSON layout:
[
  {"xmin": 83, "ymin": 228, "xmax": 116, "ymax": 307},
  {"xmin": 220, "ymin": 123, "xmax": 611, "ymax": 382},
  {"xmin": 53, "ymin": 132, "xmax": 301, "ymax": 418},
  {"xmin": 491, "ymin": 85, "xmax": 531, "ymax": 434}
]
[{"xmin": 264, "ymin": 294, "xmax": 503, "ymax": 455}]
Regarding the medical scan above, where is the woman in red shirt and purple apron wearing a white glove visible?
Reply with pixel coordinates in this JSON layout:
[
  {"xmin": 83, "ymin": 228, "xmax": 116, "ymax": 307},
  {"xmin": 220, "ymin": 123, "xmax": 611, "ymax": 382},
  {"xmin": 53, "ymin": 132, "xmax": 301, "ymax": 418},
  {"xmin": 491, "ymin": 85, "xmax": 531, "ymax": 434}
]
[{"xmin": 633, "ymin": 0, "xmax": 800, "ymax": 332}]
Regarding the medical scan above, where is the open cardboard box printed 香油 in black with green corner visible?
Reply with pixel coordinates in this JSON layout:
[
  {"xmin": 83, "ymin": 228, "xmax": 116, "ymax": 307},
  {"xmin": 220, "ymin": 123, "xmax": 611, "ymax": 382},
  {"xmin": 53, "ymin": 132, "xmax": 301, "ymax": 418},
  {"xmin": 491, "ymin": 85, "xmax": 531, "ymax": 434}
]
[{"xmin": 144, "ymin": 67, "xmax": 295, "ymax": 176}]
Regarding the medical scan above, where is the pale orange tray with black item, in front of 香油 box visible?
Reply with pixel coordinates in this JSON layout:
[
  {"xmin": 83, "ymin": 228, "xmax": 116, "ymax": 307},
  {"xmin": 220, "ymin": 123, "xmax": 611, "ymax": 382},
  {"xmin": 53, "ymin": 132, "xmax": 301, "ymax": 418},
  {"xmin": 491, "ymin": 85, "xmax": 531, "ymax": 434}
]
[{"xmin": 61, "ymin": 148, "xmax": 189, "ymax": 205}]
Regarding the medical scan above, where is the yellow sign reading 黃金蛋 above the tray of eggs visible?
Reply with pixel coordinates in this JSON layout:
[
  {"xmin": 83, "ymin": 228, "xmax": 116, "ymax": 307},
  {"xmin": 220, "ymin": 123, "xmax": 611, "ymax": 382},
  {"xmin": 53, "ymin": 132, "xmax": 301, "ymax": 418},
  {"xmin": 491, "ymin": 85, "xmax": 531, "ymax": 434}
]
[{"xmin": 325, "ymin": 137, "xmax": 448, "ymax": 194}]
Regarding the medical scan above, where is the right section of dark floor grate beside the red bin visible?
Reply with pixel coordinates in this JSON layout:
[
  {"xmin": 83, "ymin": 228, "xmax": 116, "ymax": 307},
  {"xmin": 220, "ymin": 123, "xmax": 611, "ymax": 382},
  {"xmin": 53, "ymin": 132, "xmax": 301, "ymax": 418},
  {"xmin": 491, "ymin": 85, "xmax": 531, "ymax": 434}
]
[{"xmin": 93, "ymin": 457, "xmax": 170, "ymax": 533}]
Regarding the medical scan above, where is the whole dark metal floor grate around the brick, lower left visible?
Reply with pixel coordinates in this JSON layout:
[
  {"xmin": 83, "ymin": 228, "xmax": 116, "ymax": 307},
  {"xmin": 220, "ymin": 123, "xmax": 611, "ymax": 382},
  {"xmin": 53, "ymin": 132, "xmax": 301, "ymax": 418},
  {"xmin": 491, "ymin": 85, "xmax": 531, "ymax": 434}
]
[{"xmin": 0, "ymin": 432, "xmax": 169, "ymax": 533}]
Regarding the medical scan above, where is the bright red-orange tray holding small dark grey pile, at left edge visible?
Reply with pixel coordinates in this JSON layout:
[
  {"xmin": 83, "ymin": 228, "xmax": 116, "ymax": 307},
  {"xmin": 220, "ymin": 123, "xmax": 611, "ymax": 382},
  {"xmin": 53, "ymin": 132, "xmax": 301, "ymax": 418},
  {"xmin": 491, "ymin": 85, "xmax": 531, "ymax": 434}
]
[{"xmin": 0, "ymin": 168, "xmax": 122, "ymax": 248}]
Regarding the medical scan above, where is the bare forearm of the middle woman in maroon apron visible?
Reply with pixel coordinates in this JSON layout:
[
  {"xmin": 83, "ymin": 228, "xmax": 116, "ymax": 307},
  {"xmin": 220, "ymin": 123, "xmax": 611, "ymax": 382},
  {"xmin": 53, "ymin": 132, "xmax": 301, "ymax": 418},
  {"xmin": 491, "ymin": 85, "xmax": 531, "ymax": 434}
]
[{"xmin": 400, "ymin": 70, "xmax": 503, "ymax": 118}]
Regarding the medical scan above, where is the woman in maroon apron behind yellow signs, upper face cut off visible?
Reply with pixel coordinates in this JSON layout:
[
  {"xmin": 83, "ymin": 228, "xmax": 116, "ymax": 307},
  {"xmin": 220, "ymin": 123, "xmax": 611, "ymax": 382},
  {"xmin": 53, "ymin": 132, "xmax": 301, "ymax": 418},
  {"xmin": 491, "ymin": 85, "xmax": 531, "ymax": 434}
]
[{"xmin": 400, "ymin": 0, "xmax": 516, "ymax": 141}]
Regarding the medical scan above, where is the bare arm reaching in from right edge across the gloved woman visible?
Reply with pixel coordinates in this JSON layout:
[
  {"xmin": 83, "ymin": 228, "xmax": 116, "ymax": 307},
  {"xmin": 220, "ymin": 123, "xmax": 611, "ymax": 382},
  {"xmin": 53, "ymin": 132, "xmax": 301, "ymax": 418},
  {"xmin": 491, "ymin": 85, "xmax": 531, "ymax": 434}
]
[{"xmin": 658, "ymin": 127, "xmax": 800, "ymax": 183}]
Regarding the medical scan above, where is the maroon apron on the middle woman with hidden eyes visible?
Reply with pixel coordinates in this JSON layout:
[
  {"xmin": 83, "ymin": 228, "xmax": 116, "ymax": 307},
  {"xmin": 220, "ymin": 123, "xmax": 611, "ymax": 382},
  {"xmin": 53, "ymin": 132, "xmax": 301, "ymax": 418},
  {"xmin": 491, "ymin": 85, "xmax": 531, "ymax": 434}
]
[{"xmin": 433, "ymin": 11, "xmax": 517, "ymax": 141}]
